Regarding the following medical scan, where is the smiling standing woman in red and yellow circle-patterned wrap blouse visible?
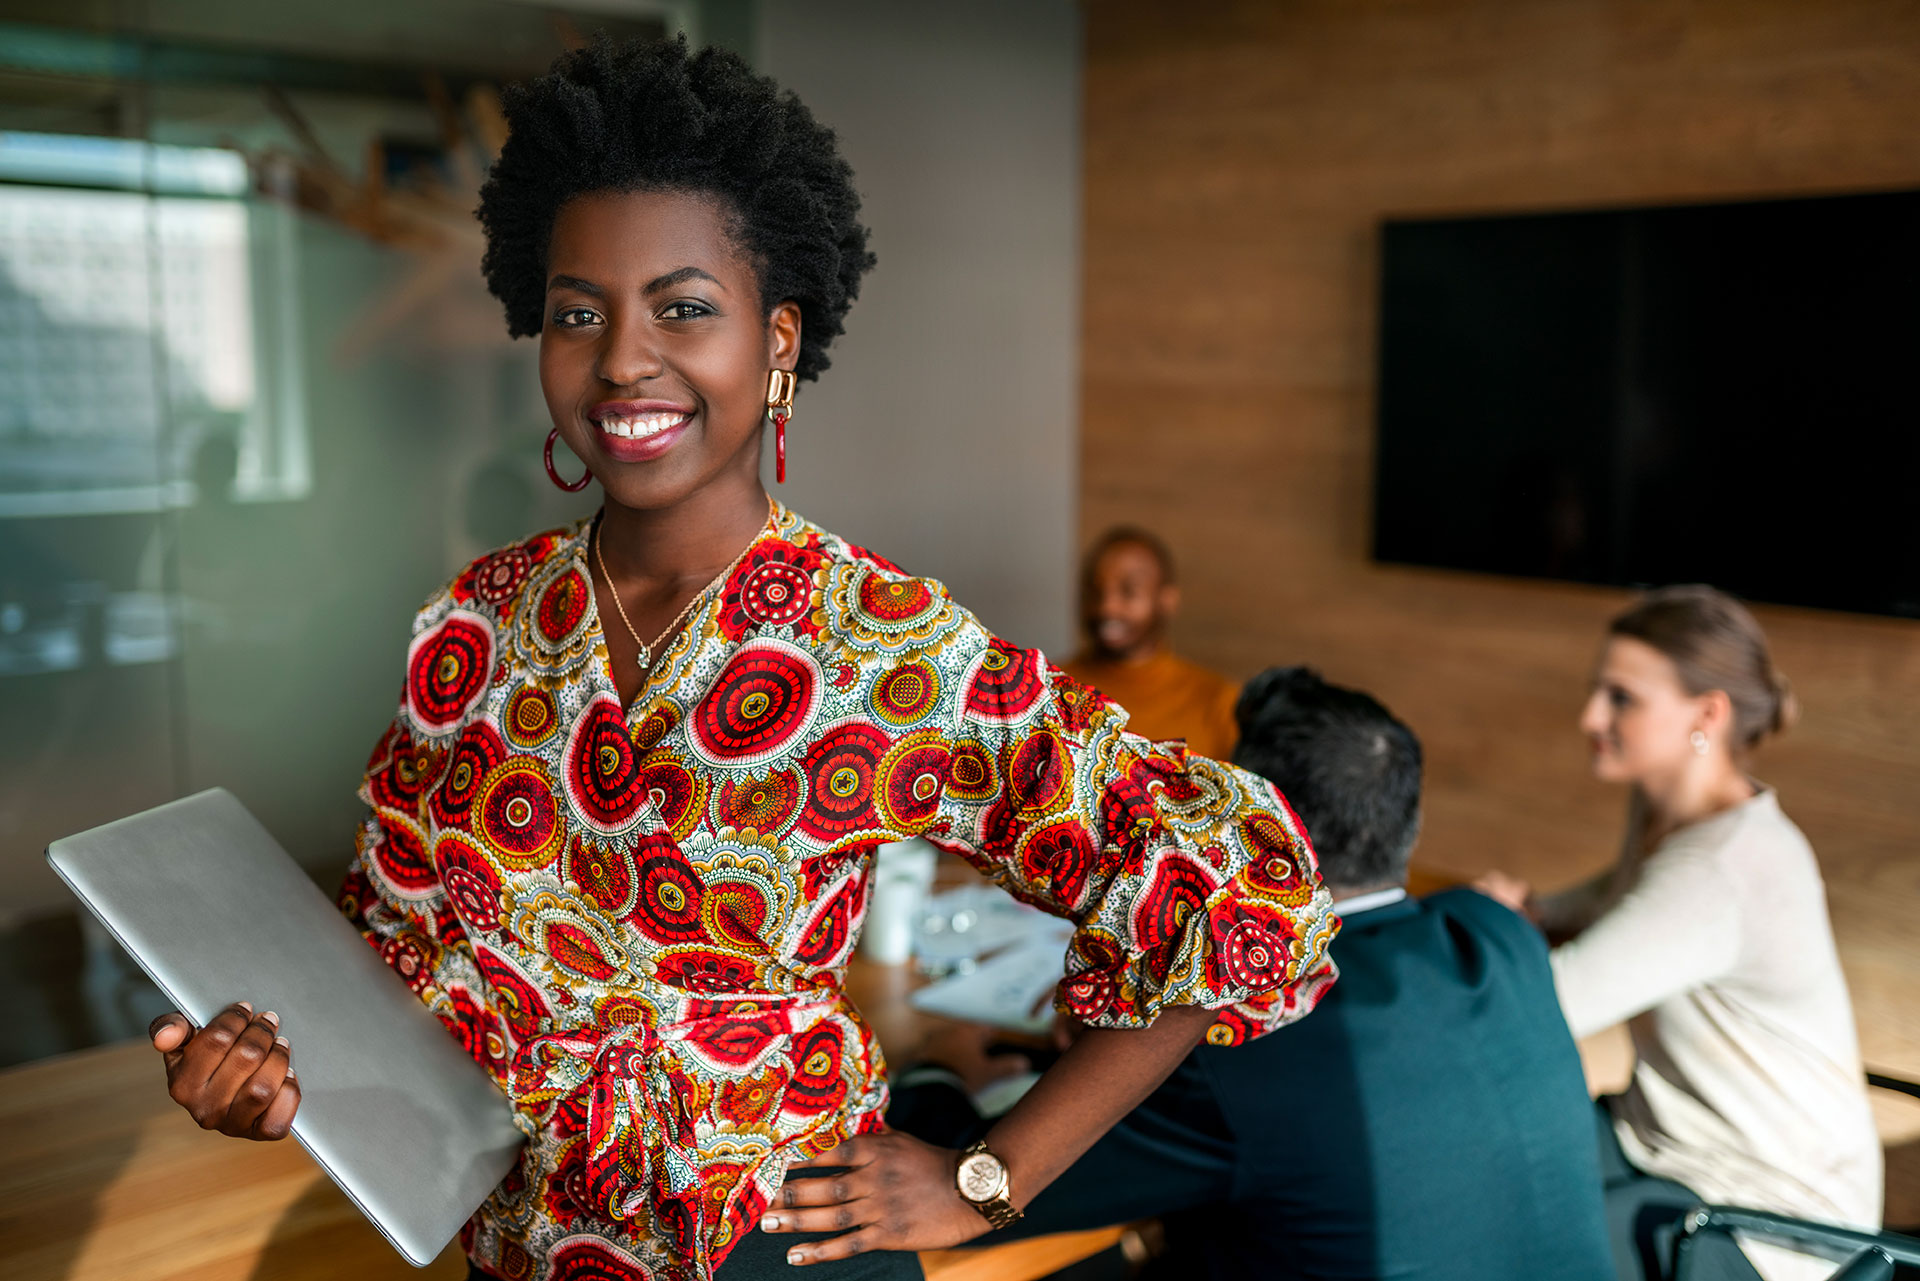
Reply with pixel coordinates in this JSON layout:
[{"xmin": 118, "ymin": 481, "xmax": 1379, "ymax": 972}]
[{"xmin": 139, "ymin": 32, "xmax": 1334, "ymax": 1281}]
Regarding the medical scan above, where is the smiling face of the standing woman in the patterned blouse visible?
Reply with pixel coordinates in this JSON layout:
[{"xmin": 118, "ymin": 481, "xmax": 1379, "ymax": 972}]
[{"xmin": 540, "ymin": 192, "xmax": 801, "ymax": 509}]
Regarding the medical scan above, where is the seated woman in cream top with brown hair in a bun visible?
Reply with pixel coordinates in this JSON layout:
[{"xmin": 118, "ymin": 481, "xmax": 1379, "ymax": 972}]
[{"xmin": 1480, "ymin": 586, "xmax": 1882, "ymax": 1281}]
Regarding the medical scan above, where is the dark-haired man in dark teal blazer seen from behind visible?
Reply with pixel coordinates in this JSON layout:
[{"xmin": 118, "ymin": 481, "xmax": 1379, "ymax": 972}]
[{"xmin": 889, "ymin": 668, "xmax": 1613, "ymax": 1281}]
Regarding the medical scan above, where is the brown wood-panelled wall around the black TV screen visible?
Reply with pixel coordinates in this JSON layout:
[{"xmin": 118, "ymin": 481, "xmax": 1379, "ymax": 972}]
[{"xmin": 1081, "ymin": 0, "xmax": 1920, "ymax": 1076}]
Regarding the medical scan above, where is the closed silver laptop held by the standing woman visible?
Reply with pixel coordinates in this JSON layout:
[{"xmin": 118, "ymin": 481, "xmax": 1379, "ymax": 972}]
[{"xmin": 46, "ymin": 787, "xmax": 522, "ymax": 1266}]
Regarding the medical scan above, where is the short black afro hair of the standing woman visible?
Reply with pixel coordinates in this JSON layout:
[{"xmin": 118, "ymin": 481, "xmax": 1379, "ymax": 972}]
[{"xmin": 478, "ymin": 36, "xmax": 874, "ymax": 378}]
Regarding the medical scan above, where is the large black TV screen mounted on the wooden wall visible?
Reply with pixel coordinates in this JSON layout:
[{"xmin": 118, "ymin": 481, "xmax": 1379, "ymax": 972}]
[{"xmin": 1373, "ymin": 192, "xmax": 1920, "ymax": 616}]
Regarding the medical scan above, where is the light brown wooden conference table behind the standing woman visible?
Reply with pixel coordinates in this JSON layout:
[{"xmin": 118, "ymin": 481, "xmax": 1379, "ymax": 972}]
[{"xmin": 0, "ymin": 958, "xmax": 1121, "ymax": 1281}]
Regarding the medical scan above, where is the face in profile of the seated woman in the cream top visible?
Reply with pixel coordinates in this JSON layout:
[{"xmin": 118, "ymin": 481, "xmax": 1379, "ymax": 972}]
[{"xmin": 1580, "ymin": 636, "xmax": 1713, "ymax": 784}]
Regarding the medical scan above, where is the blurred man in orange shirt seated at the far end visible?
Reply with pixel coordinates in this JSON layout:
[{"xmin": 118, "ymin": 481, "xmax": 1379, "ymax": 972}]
[{"xmin": 1064, "ymin": 526, "xmax": 1240, "ymax": 761}]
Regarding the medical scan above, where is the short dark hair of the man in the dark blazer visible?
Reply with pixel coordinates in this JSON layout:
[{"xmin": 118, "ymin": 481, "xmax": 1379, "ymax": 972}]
[{"xmin": 1233, "ymin": 666, "xmax": 1421, "ymax": 887}]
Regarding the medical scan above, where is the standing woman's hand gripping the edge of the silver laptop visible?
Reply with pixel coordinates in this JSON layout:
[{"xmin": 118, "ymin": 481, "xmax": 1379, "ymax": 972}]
[{"xmin": 148, "ymin": 1001, "xmax": 300, "ymax": 1141}]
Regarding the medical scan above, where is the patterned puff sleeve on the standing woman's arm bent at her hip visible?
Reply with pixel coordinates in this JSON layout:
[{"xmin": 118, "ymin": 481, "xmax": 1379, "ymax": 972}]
[{"xmin": 925, "ymin": 636, "xmax": 1338, "ymax": 1045}]
